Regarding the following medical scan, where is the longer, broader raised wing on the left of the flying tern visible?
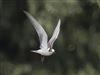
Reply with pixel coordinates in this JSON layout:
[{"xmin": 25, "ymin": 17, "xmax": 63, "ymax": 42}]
[{"xmin": 24, "ymin": 11, "xmax": 48, "ymax": 48}]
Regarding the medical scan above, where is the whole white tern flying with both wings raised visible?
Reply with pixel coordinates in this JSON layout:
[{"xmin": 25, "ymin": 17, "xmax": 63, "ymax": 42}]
[{"xmin": 24, "ymin": 11, "xmax": 61, "ymax": 62}]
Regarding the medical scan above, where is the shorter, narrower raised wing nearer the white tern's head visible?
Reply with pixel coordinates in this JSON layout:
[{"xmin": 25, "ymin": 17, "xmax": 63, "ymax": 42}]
[{"xmin": 48, "ymin": 19, "xmax": 61, "ymax": 48}]
